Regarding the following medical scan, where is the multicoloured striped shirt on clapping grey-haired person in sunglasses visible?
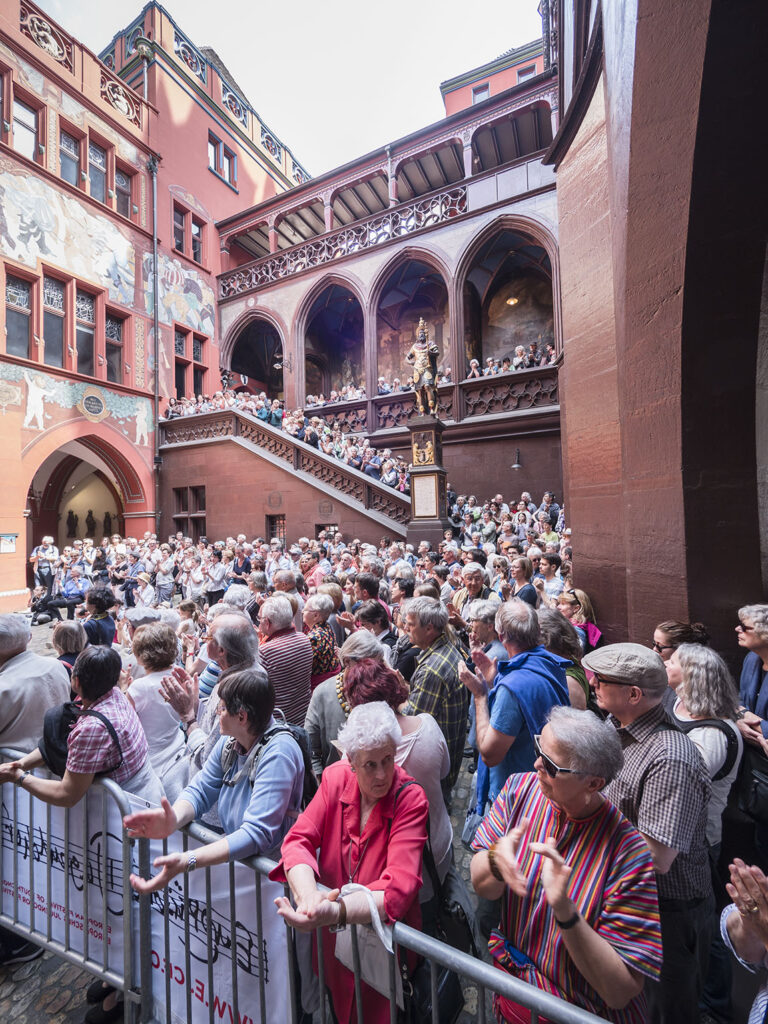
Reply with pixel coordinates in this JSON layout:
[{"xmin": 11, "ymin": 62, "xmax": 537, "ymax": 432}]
[{"xmin": 472, "ymin": 773, "xmax": 662, "ymax": 1024}]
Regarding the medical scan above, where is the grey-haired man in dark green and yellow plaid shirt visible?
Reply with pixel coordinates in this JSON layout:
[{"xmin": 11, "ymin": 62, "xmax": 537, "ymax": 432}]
[{"xmin": 403, "ymin": 597, "xmax": 469, "ymax": 808}]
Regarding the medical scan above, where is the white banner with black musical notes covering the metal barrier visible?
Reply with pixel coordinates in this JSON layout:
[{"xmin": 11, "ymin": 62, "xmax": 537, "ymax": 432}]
[{"xmin": 0, "ymin": 783, "xmax": 290, "ymax": 1024}]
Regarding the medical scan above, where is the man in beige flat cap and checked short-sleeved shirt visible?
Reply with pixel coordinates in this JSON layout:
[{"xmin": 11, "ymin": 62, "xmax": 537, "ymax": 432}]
[{"xmin": 582, "ymin": 643, "xmax": 715, "ymax": 1024}]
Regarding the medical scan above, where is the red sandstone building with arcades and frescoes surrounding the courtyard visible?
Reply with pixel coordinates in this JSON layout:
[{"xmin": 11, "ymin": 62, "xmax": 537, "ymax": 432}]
[{"xmin": 0, "ymin": 0, "xmax": 768, "ymax": 650}]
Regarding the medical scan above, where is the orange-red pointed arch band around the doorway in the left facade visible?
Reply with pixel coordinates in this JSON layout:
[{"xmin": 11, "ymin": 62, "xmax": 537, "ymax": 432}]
[{"xmin": 22, "ymin": 420, "xmax": 154, "ymax": 509}]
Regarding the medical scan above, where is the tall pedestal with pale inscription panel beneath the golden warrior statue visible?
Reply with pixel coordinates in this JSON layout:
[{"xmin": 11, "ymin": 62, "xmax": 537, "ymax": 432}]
[{"xmin": 408, "ymin": 416, "xmax": 451, "ymax": 549}]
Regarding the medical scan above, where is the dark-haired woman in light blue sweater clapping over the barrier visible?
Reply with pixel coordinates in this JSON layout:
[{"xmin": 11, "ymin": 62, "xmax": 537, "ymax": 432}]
[{"xmin": 124, "ymin": 668, "xmax": 304, "ymax": 893}]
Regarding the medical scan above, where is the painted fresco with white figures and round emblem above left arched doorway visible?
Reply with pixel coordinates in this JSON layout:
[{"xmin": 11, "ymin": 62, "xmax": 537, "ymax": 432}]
[{"xmin": 0, "ymin": 362, "xmax": 152, "ymax": 446}]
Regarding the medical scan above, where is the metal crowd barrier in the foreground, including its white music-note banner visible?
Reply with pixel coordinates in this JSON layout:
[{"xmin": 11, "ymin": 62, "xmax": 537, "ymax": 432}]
[{"xmin": 0, "ymin": 751, "xmax": 601, "ymax": 1024}]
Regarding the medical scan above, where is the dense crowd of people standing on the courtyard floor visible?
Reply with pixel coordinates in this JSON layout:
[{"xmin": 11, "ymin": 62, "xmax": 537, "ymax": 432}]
[{"xmin": 6, "ymin": 493, "xmax": 768, "ymax": 1024}]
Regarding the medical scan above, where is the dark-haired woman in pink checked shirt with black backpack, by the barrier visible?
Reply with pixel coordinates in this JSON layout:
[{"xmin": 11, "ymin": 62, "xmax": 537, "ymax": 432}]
[{"xmin": 0, "ymin": 646, "xmax": 163, "ymax": 807}]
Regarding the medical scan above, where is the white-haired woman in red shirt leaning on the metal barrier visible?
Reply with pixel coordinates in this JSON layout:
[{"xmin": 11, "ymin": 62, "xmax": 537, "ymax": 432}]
[{"xmin": 270, "ymin": 701, "xmax": 429, "ymax": 1024}]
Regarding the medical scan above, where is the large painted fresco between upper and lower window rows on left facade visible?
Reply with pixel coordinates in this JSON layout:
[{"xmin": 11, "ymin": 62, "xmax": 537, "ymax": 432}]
[{"xmin": 0, "ymin": 158, "xmax": 136, "ymax": 306}]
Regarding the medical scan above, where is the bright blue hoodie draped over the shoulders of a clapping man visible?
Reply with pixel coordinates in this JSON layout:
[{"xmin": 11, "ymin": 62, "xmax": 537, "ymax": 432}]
[{"xmin": 477, "ymin": 645, "xmax": 570, "ymax": 814}]
